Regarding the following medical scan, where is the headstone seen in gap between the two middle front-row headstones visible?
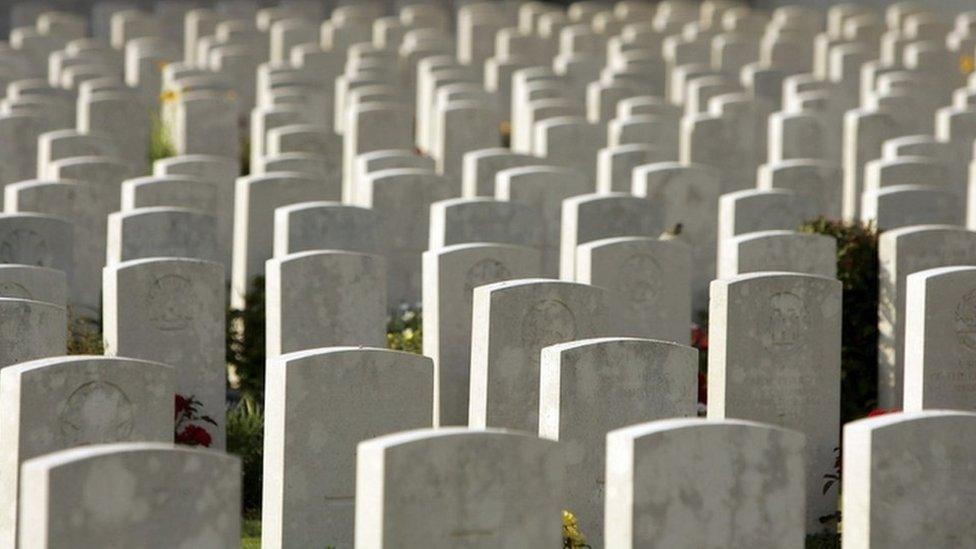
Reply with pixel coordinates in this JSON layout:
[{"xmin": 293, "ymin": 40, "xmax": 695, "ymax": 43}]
[{"xmin": 539, "ymin": 337, "xmax": 698, "ymax": 546}]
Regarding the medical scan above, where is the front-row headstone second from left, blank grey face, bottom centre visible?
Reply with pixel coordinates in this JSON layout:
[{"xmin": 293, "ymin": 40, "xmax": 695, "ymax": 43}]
[{"xmin": 356, "ymin": 428, "xmax": 564, "ymax": 549}]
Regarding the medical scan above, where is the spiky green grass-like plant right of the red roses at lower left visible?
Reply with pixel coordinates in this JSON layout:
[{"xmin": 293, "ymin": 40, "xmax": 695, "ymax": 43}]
[{"xmin": 227, "ymin": 401, "xmax": 264, "ymax": 512}]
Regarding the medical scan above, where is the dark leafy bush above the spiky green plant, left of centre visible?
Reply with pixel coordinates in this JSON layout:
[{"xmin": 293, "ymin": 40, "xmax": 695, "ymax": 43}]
[{"xmin": 226, "ymin": 277, "xmax": 265, "ymax": 406}]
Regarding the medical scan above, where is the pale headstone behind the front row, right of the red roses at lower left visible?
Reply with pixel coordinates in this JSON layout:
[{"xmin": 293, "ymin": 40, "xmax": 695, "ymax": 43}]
[{"xmin": 262, "ymin": 347, "xmax": 434, "ymax": 547}]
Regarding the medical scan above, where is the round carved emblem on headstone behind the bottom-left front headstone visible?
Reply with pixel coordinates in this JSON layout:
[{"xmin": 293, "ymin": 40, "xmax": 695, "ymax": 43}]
[{"xmin": 58, "ymin": 381, "xmax": 133, "ymax": 447}]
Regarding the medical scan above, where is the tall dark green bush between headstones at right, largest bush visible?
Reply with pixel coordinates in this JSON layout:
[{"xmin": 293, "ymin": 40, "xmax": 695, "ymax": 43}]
[{"xmin": 800, "ymin": 217, "xmax": 878, "ymax": 423}]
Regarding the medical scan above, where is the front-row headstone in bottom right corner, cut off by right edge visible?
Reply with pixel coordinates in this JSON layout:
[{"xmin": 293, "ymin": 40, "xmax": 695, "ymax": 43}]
[{"xmin": 841, "ymin": 411, "xmax": 976, "ymax": 548}]
